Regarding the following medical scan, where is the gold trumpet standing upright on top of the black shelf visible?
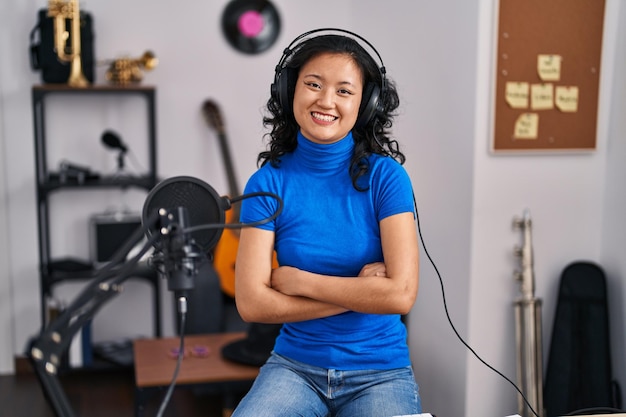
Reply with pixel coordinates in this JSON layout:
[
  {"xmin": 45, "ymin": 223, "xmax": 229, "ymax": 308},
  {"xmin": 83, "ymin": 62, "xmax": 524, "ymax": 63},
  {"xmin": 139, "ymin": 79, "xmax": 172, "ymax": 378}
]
[{"xmin": 48, "ymin": 0, "xmax": 89, "ymax": 87}]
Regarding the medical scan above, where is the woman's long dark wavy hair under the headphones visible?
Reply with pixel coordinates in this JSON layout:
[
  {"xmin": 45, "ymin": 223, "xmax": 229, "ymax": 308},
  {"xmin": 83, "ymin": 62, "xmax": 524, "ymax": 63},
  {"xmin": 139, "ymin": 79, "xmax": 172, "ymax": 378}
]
[{"xmin": 257, "ymin": 34, "xmax": 405, "ymax": 190}]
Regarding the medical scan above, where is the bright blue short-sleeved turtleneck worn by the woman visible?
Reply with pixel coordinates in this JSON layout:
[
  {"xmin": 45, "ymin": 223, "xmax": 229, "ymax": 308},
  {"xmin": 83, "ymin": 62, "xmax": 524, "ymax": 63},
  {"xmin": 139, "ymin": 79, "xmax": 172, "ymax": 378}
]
[{"xmin": 241, "ymin": 133, "xmax": 414, "ymax": 370}]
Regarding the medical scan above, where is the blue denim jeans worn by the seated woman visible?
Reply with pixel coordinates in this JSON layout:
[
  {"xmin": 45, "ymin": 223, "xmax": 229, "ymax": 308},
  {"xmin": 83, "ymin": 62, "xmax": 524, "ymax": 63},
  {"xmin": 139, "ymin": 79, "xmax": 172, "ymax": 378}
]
[{"xmin": 233, "ymin": 353, "xmax": 422, "ymax": 417}]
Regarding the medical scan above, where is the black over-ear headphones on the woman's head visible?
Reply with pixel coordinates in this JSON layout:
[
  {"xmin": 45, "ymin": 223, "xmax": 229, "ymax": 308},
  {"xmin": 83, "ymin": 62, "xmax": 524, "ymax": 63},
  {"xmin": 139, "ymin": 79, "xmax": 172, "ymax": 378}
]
[{"xmin": 271, "ymin": 28, "xmax": 387, "ymax": 128}]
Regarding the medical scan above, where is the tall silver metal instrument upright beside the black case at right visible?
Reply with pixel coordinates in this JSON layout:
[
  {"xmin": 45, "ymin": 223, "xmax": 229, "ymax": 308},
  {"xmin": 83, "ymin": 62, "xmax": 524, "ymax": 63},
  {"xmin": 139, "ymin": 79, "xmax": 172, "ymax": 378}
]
[{"xmin": 513, "ymin": 210, "xmax": 544, "ymax": 417}]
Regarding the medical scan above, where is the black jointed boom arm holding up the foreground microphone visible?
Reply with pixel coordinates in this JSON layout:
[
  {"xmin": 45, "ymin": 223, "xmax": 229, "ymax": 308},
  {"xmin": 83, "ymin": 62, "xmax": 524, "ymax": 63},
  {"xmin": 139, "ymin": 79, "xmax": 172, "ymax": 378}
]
[{"xmin": 29, "ymin": 210, "xmax": 194, "ymax": 417}]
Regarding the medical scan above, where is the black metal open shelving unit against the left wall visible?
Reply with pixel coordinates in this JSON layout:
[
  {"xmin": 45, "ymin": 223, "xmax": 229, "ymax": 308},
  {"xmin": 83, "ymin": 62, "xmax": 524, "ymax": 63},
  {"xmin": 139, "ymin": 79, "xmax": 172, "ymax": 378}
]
[{"xmin": 32, "ymin": 84, "xmax": 161, "ymax": 337}]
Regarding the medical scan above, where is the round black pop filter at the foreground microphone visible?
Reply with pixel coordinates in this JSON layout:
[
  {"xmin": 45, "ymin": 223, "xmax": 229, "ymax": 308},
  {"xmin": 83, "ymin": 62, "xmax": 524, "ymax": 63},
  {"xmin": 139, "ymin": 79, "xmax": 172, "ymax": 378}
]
[{"xmin": 141, "ymin": 176, "xmax": 230, "ymax": 253}]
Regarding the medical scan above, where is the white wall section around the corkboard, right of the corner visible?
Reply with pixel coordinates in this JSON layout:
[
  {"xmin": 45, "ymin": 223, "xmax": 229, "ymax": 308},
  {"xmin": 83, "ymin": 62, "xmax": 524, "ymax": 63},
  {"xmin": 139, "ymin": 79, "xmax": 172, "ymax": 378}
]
[{"xmin": 466, "ymin": 0, "xmax": 625, "ymax": 416}]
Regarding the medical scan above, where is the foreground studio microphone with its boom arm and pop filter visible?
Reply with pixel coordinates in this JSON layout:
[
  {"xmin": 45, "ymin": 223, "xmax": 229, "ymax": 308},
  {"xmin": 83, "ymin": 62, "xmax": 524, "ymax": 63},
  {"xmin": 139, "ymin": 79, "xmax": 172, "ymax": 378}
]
[{"xmin": 28, "ymin": 175, "xmax": 283, "ymax": 417}]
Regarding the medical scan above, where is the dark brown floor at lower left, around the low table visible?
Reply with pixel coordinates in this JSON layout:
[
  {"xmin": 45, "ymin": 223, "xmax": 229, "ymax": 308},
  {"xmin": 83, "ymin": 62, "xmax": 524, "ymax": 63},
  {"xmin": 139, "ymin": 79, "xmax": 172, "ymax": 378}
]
[{"xmin": 0, "ymin": 369, "xmax": 222, "ymax": 417}]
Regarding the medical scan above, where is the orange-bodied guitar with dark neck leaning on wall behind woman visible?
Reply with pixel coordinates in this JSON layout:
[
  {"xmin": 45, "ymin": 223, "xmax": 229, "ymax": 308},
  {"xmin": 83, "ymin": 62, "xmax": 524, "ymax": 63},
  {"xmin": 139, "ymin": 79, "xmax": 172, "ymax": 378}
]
[{"xmin": 202, "ymin": 100, "xmax": 240, "ymax": 297}]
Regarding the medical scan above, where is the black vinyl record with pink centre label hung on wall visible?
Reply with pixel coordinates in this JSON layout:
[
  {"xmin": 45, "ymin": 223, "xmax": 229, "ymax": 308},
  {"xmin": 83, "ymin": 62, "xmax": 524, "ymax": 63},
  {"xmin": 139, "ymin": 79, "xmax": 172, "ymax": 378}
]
[{"xmin": 222, "ymin": 0, "xmax": 280, "ymax": 54}]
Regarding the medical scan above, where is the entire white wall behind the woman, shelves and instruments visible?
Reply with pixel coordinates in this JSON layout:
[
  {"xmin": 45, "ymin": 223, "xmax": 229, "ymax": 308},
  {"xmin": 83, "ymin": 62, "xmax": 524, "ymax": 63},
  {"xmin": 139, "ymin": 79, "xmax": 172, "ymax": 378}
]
[{"xmin": 0, "ymin": 0, "xmax": 626, "ymax": 417}]
